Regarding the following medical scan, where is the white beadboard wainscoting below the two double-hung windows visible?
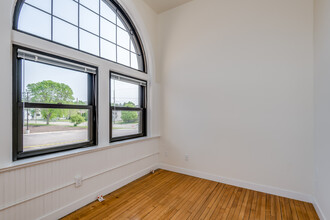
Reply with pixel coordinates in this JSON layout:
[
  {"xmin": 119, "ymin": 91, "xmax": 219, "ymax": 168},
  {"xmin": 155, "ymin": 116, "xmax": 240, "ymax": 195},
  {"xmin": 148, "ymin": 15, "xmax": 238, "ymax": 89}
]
[{"xmin": 0, "ymin": 137, "xmax": 159, "ymax": 220}]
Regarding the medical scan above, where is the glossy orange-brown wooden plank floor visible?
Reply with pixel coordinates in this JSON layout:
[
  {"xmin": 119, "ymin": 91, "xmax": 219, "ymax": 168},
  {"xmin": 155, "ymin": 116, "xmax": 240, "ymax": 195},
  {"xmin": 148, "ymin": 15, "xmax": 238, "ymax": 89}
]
[{"xmin": 63, "ymin": 170, "xmax": 319, "ymax": 220}]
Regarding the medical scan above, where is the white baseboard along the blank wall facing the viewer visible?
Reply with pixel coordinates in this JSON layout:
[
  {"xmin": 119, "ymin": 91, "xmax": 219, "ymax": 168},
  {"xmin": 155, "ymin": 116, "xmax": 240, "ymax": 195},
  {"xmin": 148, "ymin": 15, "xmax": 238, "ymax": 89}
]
[{"xmin": 159, "ymin": 163, "xmax": 314, "ymax": 203}]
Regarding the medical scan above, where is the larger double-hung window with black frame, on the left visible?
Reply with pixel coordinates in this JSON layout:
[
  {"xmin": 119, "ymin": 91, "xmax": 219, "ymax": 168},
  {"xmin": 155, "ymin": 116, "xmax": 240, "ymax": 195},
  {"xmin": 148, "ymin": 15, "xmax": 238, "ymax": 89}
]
[{"xmin": 13, "ymin": 46, "xmax": 97, "ymax": 160}]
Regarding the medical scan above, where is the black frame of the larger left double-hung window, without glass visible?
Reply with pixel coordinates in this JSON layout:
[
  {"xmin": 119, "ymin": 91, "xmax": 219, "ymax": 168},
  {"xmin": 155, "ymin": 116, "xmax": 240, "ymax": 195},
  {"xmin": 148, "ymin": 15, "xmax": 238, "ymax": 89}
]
[{"xmin": 12, "ymin": 45, "xmax": 98, "ymax": 161}]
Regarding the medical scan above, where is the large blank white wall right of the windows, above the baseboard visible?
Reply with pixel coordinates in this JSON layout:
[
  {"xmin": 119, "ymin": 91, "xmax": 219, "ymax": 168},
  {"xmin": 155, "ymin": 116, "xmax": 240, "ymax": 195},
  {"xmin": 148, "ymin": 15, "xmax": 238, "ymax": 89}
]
[{"xmin": 159, "ymin": 0, "xmax": 314, "ymax": 195}]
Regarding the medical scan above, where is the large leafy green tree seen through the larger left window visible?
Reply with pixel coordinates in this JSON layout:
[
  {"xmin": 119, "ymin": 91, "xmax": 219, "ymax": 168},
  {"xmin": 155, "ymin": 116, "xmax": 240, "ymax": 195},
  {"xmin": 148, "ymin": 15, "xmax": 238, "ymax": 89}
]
[{"xmin": 27, "ymin": 80, "xmax": 74, "ymax": 125}]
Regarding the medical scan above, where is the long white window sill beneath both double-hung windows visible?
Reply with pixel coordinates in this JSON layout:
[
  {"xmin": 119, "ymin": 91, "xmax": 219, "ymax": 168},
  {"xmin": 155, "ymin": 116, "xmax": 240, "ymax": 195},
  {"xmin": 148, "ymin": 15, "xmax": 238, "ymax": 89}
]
[{"xmin": 0, "ymin": 136, "xmax": 160, "ymax": 173}]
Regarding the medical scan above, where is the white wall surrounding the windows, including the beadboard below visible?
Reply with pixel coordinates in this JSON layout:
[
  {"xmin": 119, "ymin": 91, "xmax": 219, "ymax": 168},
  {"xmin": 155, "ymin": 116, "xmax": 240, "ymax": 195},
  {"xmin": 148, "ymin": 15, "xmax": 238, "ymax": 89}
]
[{"xmin": 0, "ymin": 0, "xmax": 160, "ymax": 220}]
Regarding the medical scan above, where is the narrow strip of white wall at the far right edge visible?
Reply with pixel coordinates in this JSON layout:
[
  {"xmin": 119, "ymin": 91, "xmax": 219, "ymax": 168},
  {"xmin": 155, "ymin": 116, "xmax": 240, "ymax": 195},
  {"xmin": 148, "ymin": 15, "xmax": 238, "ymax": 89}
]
[{"xmin": 315, "ymin": 0, "xmax": 330, "ymax": 219}]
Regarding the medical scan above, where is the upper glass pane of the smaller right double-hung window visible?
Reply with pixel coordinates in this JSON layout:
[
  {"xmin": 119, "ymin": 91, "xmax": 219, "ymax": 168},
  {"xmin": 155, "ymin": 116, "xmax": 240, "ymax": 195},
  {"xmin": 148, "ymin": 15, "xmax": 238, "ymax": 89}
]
[{"xmin": 111, "ymin": 79, "xmax": 140, "ymax": 108}]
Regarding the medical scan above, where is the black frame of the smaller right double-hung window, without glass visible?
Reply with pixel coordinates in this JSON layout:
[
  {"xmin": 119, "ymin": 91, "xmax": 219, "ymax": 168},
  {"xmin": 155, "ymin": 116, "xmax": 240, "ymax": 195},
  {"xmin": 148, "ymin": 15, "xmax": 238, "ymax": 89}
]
[{"xmin": 109, "ymin": 71, "xmax": 148, "ymax": 143}]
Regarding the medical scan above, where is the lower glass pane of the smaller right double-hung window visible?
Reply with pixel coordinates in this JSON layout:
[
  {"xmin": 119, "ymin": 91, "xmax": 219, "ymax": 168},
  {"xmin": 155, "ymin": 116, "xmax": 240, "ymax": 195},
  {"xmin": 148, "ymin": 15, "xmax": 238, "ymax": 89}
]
[{"xmin": 112, "ymin": 111, "xmax": 142, "ymax": 138}]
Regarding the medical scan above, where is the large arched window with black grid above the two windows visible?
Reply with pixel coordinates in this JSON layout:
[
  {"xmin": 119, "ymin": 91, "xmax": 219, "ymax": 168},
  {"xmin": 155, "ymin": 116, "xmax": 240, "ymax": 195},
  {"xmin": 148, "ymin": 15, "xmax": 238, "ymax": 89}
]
[{"xmin": 14, "ymin": 0, "xmax": 146, "ymax": 72}]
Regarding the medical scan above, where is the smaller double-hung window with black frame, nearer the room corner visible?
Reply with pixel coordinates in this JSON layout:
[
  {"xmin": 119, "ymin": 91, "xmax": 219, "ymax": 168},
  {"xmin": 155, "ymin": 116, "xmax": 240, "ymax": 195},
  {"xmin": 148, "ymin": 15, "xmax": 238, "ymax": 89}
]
[{"xmin": 110, "ymin": 73, "xmax": 147, "ymax": 142}]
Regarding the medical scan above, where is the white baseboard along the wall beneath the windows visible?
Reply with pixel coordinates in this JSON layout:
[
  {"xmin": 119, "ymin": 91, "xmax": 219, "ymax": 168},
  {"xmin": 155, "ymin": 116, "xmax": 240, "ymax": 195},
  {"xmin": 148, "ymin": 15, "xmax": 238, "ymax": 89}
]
[{"xmin": 40, "ymin": 165, "xmax": 158, "ymax": 220}]
